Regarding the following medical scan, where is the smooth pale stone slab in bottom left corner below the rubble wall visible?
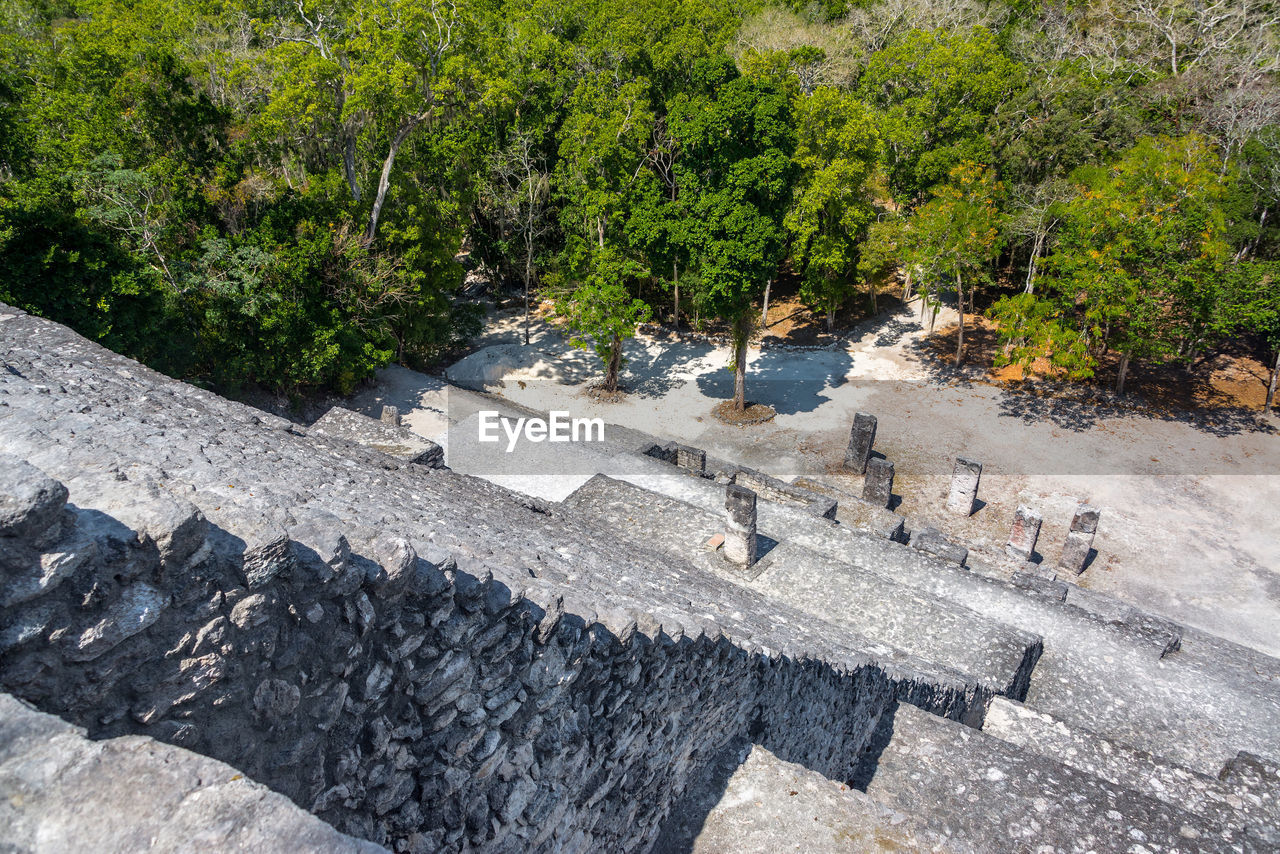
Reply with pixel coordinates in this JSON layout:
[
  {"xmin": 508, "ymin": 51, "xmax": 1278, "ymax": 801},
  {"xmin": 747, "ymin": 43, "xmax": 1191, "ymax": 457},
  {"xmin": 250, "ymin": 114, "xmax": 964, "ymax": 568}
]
[{"xmin": 0, "ymin": 694, "xmax": 387, "ymax": 854}]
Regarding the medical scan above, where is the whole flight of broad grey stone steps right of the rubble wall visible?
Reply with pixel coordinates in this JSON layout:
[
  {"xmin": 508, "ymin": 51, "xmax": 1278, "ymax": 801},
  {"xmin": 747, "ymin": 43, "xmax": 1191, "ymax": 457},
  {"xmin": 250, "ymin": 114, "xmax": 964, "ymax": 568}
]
[{"xmin": 564, "ymin": 476, "xmax": 1280, "ymax": 851}]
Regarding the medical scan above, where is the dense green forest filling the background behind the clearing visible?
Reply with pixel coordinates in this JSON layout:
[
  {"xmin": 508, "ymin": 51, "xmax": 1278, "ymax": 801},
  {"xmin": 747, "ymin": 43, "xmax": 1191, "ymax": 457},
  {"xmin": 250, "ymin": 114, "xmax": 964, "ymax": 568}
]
[{"xmin": 0, "ymin": 0, "xmax": 1280, "ymax": 406}]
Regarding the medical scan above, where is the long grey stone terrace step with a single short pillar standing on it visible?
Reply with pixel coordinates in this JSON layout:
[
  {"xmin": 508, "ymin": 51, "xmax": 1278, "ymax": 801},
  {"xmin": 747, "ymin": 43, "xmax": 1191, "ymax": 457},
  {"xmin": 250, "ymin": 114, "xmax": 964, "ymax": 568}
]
[{"xmin": 564, "ymin": 475, "xmax": 1041, "ymax": 697}]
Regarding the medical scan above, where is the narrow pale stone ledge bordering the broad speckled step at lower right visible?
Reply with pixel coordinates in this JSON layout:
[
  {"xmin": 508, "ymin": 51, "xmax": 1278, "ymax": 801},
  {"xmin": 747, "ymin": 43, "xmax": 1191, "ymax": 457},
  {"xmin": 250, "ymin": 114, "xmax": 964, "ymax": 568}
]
[{"xmin": 982, "ymin": 697, "xmax": 1280, "ymax": 844}]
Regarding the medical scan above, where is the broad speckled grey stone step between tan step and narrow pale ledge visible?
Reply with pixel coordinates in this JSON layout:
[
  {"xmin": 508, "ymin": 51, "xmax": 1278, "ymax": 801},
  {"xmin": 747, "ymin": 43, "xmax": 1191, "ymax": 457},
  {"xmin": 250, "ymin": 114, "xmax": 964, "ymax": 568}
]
[{"xmin": 854, "ymin": 704, "xmax": 1271, "ymax": 854}]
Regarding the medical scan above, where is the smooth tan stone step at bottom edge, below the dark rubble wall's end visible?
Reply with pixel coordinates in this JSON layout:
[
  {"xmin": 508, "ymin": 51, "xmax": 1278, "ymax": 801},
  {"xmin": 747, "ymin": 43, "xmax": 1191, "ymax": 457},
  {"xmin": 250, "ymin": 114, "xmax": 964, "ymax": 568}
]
[{"xmin": 652, "ymin": 745, "xmax": 977, "ymax": 854}]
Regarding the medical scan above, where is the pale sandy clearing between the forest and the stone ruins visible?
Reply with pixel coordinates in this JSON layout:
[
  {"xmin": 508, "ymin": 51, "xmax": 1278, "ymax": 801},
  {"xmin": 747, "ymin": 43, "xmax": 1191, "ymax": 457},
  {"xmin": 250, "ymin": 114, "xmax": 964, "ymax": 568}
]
[{"xmin": 353, "ymin": 306, "xmax": 1280, "ymax": 656}]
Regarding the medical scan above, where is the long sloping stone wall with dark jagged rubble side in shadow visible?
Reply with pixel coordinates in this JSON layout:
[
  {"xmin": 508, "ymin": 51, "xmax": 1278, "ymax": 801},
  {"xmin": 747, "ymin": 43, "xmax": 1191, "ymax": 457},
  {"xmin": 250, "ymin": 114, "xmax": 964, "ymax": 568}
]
[{"xmin": 0, "ymin": 306, "xmax": 978, "ymax": 851}]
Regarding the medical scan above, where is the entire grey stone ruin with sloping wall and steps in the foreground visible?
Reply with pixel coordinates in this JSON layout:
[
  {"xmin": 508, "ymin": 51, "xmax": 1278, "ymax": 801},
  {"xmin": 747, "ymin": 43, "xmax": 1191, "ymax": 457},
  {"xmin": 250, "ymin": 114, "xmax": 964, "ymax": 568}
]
[{"xmin": 0, "ymin": 307, "xmax": 1280, "ymax": 853}]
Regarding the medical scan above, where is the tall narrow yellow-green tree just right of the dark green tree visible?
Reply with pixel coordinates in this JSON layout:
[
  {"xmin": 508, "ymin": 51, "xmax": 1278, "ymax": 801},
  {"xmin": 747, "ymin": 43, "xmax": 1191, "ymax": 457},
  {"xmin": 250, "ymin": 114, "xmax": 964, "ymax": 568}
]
[{"xmin": 786, "ymin": 87, "xmax": 879, "ymax": 332}]
